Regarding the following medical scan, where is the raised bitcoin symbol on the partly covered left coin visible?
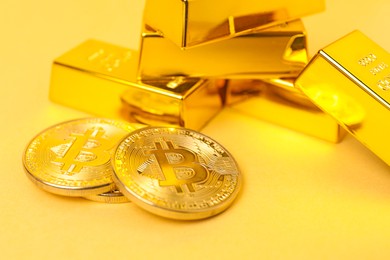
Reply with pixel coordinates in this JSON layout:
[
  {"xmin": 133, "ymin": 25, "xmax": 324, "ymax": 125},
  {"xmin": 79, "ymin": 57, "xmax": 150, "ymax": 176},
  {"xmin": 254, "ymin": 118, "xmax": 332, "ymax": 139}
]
[{"xmin": 54, "ymin": 128, "xmax": 110, "ymax": 175}]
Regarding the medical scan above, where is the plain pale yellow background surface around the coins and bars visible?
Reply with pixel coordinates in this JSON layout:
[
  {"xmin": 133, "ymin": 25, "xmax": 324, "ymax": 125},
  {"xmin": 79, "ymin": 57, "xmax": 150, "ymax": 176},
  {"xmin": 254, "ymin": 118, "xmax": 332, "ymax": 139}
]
[{"xmin": 0, "ymin": 0, "xmax": 390, "ymax": 259}]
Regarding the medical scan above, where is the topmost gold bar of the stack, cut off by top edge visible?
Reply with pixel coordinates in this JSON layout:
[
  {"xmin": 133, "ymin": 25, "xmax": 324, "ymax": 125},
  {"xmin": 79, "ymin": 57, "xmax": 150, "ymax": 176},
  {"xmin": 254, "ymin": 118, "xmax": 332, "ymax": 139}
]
[{"xmin": 144, "ymin": 0, "xmax": 325, "ymax": 48}]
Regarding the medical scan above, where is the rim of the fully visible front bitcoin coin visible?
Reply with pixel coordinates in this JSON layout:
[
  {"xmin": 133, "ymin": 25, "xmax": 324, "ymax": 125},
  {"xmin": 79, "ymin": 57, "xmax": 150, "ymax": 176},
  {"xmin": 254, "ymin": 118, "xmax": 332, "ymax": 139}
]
[{"xmin": 111, "ymin": 126, "xmax": 242, "ymax": 220}]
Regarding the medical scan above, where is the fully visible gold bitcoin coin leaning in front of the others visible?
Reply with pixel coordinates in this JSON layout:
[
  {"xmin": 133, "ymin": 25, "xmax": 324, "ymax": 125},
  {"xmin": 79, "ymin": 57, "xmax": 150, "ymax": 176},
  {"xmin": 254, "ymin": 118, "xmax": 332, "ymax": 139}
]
[{"xmin": 112, "ymin": 127, "xmax": 242, "ymax": 220}]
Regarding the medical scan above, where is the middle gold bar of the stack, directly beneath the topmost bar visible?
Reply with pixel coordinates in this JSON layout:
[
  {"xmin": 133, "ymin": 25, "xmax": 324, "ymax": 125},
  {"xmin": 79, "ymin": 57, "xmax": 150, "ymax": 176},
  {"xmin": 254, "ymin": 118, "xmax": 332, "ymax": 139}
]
[{"xmin": 139, "ymin": 20, "xmax": 308, "ymax": 79}]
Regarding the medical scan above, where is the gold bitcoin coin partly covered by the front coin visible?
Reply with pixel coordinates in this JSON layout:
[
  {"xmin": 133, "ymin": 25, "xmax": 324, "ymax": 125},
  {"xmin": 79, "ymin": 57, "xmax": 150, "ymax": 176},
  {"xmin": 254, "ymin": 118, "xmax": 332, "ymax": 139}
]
[{"xmin": 23, "ymin": 118, "xmax": 144, "ymax": 196}]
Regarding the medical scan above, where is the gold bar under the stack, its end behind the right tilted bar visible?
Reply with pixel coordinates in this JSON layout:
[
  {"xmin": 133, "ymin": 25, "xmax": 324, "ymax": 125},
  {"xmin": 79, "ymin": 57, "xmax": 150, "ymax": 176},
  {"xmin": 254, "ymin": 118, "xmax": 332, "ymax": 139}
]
[{"xmin": 226, "ymin": 79, "xmax": 345, "ymax": 143}]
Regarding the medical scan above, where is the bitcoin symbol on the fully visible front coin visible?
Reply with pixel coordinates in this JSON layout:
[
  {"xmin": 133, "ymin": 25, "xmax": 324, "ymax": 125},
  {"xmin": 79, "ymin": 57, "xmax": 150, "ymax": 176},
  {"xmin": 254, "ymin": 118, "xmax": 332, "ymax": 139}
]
[{"xmin": 146, "ymin": 141, "xmax": 208, "ymax": 193}]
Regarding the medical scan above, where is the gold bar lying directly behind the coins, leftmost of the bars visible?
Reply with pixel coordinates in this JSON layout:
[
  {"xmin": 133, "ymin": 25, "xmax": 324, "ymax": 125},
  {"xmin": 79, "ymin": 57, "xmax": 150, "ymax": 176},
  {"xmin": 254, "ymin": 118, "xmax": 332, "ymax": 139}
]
[{"xmin": 49, "ymin": 40, "xmax": 222, "ymax": 130}]
